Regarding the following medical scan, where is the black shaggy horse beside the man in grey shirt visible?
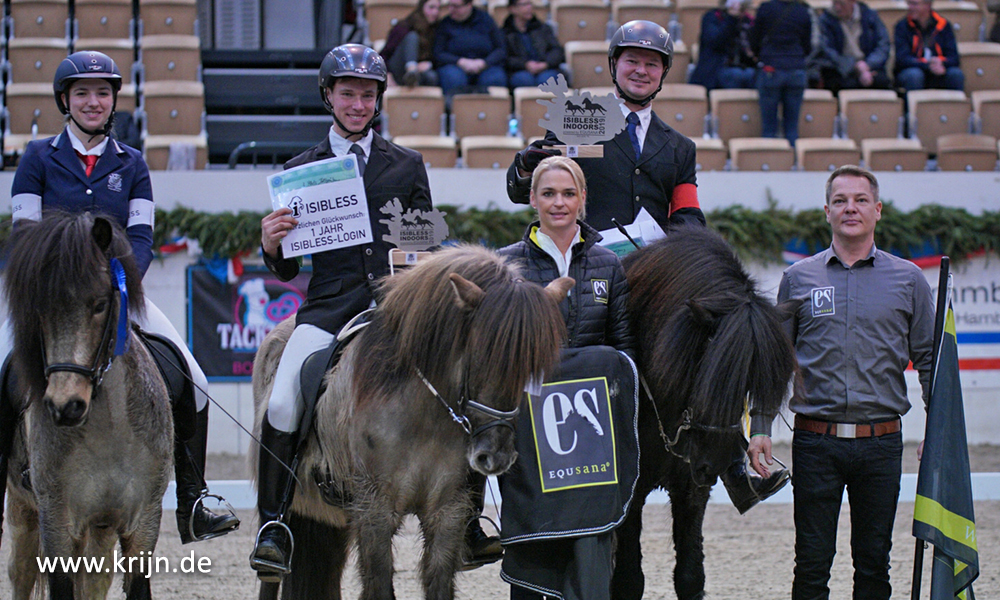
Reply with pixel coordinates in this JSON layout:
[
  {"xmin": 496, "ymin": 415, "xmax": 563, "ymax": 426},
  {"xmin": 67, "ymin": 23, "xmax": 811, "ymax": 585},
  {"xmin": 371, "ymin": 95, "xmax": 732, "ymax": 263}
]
[{"xmin": 613, "ymin": 227, "xmax": 795, "ymax": 600}]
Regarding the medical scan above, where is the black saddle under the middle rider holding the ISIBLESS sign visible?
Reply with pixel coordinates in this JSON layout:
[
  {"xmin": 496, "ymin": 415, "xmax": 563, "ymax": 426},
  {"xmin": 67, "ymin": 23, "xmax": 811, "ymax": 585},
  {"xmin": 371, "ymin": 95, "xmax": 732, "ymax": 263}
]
[{"xmin": 299, "ymin": 309, "xmax": 372, "ymax": 508}]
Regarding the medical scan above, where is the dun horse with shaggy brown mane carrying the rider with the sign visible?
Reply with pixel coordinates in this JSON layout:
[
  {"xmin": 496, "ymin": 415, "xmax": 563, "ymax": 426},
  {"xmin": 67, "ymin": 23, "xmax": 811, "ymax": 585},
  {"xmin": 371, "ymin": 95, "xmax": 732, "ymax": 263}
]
[{"xmin": 251, "ymin": 246, "xmax": 573, "ymax": 600}]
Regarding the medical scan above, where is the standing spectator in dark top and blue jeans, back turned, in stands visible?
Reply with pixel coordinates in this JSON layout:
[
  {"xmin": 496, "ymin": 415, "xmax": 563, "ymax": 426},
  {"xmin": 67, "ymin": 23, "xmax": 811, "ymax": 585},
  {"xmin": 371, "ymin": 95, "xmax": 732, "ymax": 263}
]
[{"xmin": 750, "ymin": 0, "xmax": 812, "ymax": 146}]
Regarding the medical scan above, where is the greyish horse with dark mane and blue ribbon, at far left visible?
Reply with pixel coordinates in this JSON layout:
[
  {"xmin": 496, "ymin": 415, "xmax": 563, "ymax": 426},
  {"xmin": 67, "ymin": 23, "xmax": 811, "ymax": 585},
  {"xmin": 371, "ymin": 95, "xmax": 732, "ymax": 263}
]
[{"xmin": 4, "ymin": 213, "xmax": 174, "ymax": 600}]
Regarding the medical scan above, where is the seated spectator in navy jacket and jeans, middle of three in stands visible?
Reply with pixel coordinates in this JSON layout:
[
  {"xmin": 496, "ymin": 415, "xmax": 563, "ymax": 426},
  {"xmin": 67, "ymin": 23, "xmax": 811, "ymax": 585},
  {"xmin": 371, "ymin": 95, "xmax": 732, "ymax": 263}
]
[{"xmin": 434, "ymin": 0, "xmax": 507, "ymax": 96}]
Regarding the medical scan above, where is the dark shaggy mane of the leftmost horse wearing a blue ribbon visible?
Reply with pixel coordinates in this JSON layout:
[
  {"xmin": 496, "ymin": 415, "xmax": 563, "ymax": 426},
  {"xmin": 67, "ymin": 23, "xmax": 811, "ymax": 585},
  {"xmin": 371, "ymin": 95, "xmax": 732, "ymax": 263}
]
[{"xmin": 3, "ymin": 211, "xmax": 145, "ymax": 397}]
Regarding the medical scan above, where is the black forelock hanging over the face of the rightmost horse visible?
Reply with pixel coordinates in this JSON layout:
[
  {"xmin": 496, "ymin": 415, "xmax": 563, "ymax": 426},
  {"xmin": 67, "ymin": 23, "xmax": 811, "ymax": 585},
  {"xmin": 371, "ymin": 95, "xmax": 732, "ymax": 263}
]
[{"xmin": 693, "ymin": 294, "xmax": 795, "ymax": 425}]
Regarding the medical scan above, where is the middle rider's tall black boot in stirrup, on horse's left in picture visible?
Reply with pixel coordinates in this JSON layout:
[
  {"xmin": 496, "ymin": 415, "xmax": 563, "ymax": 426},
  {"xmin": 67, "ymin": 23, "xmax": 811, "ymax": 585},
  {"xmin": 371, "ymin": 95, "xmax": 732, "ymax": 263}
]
[{"xmin": 250, "ymin": 415, "xmax": 298, "ymax": 583}]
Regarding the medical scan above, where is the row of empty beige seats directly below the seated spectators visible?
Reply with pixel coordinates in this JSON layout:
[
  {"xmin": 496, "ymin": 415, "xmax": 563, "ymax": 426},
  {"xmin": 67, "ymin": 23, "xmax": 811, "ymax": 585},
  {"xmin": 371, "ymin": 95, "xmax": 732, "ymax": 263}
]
[{"xmin": 382, "ymin": 84, "xmax": 1000, "ymax": 154}]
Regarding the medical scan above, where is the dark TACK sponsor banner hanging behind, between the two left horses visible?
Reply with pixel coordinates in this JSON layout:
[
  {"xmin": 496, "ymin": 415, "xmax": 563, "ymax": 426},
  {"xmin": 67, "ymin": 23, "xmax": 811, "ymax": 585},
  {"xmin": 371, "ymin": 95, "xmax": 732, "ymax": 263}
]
[{"xmin": 187, "ymin": 265, "xmax": 311, "ymax": 381}]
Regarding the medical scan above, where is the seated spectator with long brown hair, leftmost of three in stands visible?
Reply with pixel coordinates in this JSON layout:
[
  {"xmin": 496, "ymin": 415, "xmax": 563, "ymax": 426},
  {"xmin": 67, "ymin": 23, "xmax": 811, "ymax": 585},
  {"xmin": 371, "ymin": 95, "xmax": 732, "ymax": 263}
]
[{"xmin": 382, "ymin": 0, "xmax": 442, "ymax": 87}]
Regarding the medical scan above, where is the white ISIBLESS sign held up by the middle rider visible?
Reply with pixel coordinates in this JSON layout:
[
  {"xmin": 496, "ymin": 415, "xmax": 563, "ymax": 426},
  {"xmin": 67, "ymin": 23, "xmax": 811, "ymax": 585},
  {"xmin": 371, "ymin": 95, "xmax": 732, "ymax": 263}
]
[{"xmin": 267, "ymin": 155, "xmax": 373, "ymax": 258}]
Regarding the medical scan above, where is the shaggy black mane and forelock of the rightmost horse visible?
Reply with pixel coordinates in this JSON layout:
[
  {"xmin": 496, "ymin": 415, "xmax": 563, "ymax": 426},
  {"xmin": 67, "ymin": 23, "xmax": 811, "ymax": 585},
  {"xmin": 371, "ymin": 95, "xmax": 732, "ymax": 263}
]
[{"xmin": 623, "ymin": 227, "xmax": 795, "ymax": 426}]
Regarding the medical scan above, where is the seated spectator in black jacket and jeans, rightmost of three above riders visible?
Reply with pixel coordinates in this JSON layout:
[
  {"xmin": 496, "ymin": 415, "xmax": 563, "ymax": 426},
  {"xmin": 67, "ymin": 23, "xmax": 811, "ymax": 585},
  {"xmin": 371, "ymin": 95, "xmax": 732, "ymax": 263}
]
[{"xmin": 503, "ymin": 0, "xmax": 566, "ymax": 87}]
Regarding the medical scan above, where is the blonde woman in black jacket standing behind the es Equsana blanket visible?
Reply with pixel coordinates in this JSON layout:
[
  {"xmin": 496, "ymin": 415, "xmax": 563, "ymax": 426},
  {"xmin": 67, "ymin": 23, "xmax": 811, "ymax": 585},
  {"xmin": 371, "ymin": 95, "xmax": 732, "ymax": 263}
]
[{"xmin": 500, "ymin": 156, "xmax": 632, "ymax": 600}]
